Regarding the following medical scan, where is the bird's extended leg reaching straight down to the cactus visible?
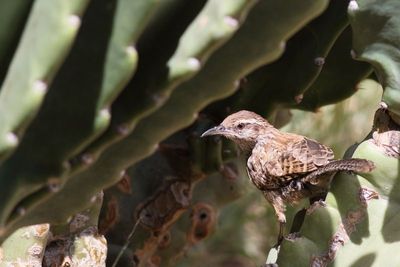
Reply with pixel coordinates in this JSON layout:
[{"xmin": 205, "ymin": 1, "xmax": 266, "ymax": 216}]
[{"xmin": 264, "ymin": 190, "xmax": 286, "ymax": 248}]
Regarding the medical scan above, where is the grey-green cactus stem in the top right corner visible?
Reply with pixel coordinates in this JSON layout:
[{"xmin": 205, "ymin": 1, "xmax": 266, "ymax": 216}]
[{"xmin": 349, "ymin": 0, "xmax": 400, "ymax": 115}]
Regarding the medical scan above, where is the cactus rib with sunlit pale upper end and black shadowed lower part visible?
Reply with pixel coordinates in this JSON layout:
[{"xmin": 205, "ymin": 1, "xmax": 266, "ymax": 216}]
[{"xmin": 71, "ymin": 0, "xmax": 254, "ymax": 171}]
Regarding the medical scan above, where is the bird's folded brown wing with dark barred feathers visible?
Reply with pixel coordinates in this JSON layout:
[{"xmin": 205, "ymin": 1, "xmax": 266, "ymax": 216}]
[{"xmin": 253, "ymin": 136, "xmax": 334, "ymax": 177}]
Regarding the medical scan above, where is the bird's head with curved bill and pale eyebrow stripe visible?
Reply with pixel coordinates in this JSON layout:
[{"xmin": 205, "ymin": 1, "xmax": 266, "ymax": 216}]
[{"xmin": 201, "ymin": 110, "xmax": 273, "ymax": 152}]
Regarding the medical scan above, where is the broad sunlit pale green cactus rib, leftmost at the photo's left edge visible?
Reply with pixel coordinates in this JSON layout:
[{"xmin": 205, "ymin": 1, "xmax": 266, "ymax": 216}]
[{"xmin": 0, "ymin": 0, "xmax": 89, "ymax": 161}]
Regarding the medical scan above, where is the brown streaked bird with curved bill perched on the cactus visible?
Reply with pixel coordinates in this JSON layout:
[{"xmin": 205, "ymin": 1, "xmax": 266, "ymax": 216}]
[{"xmin": 201, "ymin": 110, "xmax": 375, "ymax": 248}]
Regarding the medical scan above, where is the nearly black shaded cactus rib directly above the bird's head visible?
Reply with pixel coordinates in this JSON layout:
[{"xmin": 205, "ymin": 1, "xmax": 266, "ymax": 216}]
[{"xmin": 228, "ymin": 1, "xmax": 348, "ymax": 114}]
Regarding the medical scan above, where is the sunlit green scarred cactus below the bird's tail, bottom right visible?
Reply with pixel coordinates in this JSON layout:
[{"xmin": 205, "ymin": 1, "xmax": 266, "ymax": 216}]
[{"xmin": 277, "ymin": 139, "xmax": 400, "ymax": 267}]
